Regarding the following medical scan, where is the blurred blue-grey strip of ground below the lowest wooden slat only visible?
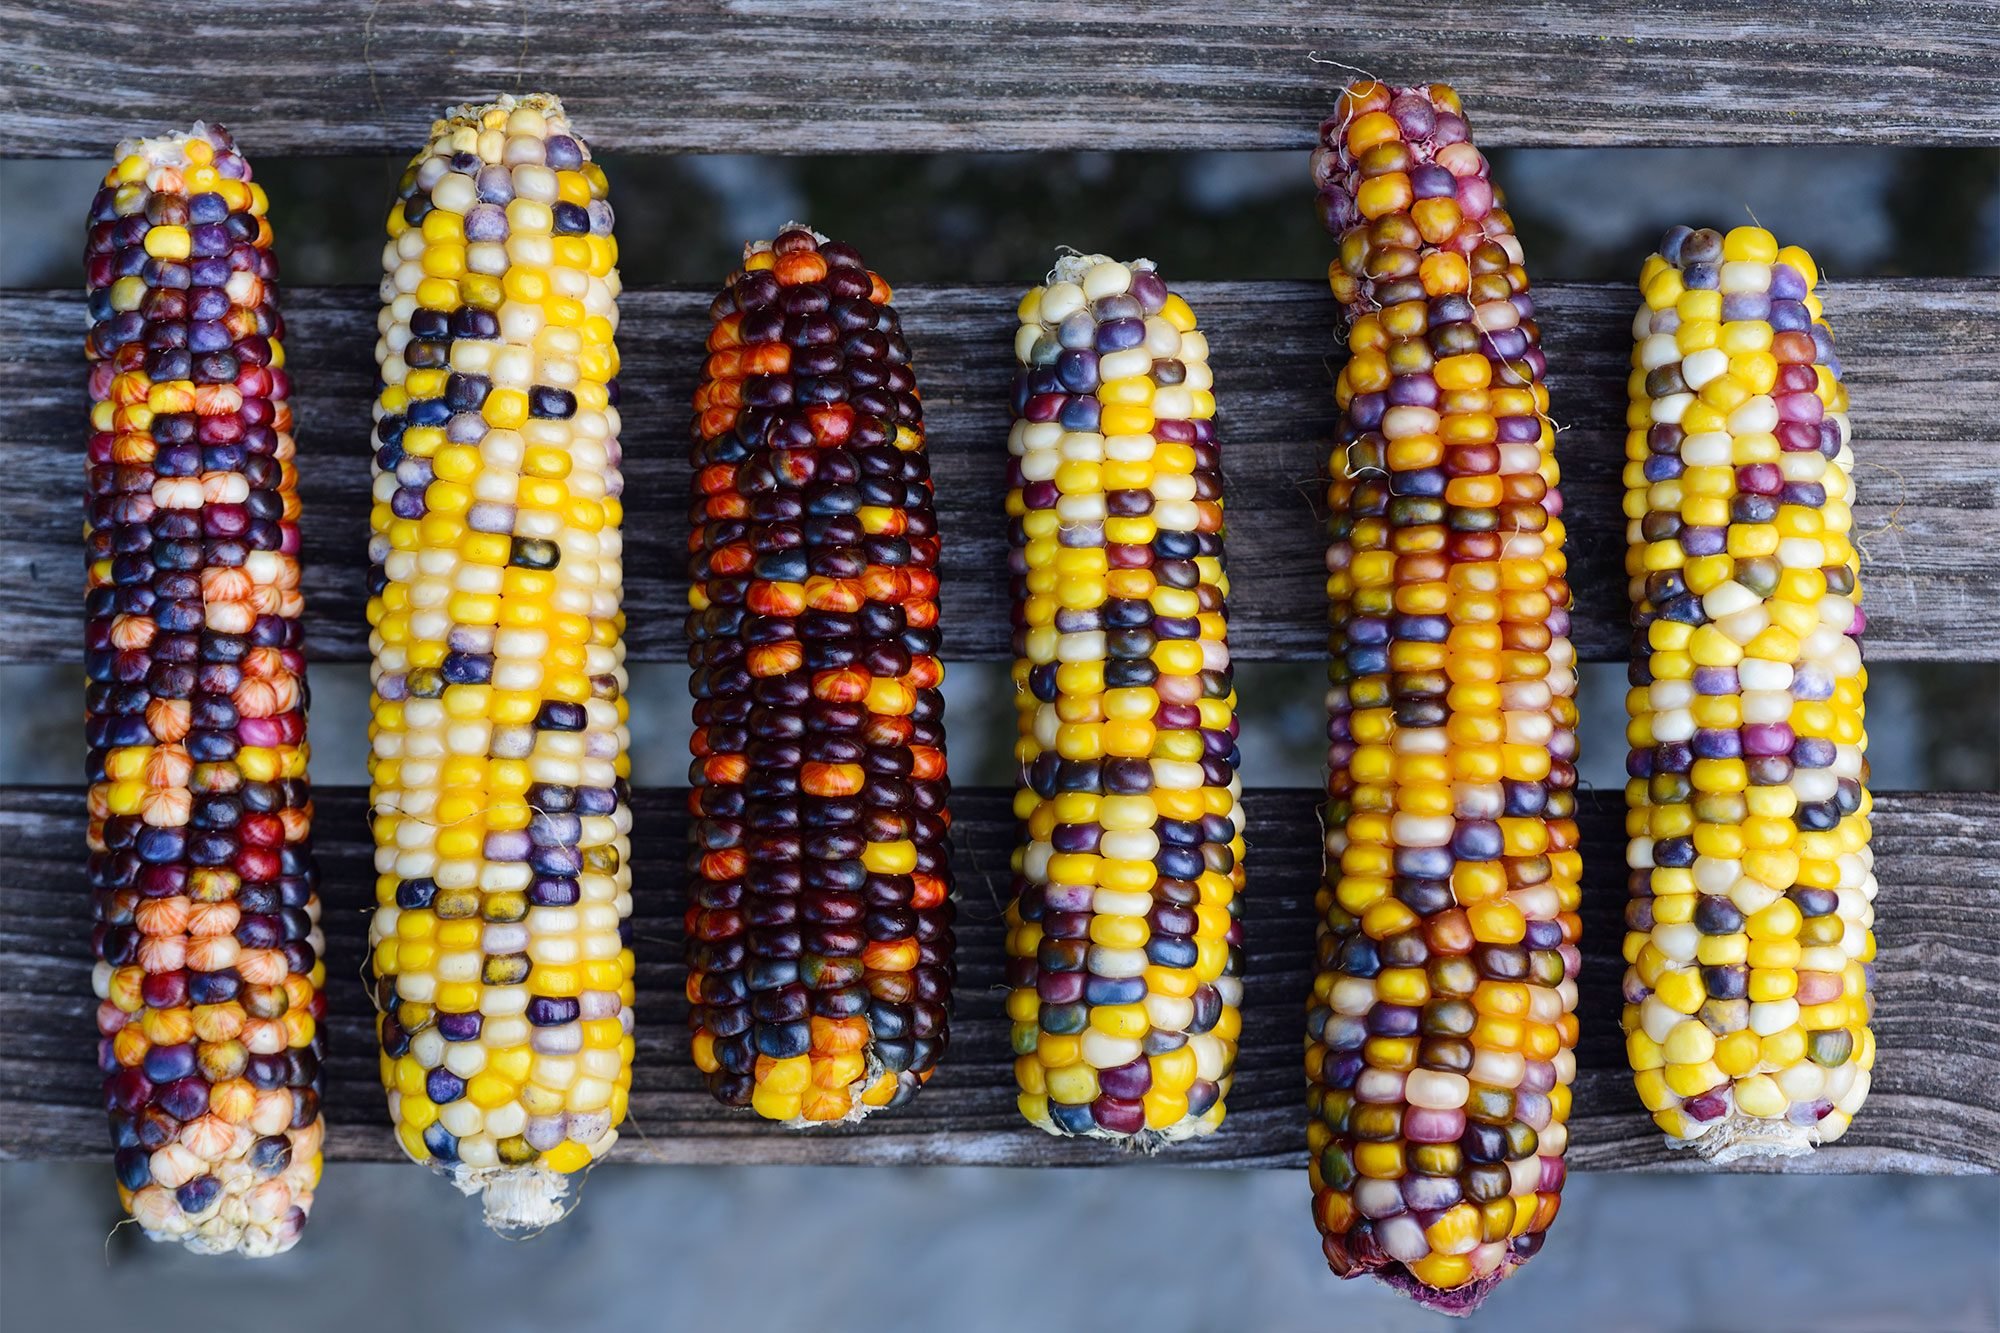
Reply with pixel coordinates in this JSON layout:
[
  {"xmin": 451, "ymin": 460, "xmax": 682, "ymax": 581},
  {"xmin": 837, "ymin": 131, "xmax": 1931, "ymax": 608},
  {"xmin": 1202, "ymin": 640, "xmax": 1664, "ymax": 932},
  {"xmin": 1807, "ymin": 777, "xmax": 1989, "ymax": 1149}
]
[{"xmin": 0, "ymin": 1163, "xmax": 2000, "ymax": 1333}]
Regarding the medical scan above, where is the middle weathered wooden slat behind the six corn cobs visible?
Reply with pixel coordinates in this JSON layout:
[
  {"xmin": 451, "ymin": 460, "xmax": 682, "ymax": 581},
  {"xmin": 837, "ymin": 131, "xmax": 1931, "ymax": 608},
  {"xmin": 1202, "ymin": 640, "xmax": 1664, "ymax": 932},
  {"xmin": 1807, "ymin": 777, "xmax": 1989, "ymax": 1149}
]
[{"xmin": 0, "ymin": 278, "xmax": 2000, "ymax": 662}]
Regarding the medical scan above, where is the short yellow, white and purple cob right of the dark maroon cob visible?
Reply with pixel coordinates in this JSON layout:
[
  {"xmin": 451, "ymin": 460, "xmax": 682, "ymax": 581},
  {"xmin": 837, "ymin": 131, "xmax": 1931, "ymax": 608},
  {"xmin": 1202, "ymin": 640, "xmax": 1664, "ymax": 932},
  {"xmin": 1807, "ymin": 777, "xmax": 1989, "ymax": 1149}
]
[{"xmin": 1006, "ymin": 254, "xmax": 1244, "ymax": 1147}]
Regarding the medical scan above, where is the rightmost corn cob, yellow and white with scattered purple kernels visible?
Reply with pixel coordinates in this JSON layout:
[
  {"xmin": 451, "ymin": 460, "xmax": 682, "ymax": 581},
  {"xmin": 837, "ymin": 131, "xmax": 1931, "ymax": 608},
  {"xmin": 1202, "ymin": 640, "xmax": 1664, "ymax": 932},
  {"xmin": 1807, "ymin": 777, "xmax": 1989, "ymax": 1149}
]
[{"xmin": 1624, "ymin": 226, "xmax": 1876, "ymax": 1161}]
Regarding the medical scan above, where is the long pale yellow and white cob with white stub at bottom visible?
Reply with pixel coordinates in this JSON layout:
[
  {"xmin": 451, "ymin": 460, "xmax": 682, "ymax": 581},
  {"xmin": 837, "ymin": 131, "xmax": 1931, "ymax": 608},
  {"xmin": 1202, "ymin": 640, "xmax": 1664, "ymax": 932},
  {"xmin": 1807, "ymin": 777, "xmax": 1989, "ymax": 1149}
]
[{"xmin": 368, "ymin": 96, "xmax": 632, "ymax": 1229}]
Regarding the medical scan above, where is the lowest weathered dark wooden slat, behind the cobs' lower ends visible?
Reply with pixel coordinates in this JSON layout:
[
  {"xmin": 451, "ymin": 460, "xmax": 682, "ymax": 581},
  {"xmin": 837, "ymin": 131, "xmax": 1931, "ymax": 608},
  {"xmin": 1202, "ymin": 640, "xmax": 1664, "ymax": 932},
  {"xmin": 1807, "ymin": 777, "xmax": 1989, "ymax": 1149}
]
[{"xmin": 0, "ymin": 789, "xmax": 2000, "ymax": 1173}]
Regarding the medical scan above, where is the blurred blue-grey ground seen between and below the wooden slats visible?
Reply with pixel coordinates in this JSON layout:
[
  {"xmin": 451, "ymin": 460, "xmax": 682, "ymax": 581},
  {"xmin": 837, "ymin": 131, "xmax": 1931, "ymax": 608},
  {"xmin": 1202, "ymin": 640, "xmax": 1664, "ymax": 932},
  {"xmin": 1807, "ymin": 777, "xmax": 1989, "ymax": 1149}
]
[{"xmin": 0, "ymin": 142, "xmax": 2000, "ymax": 1333}]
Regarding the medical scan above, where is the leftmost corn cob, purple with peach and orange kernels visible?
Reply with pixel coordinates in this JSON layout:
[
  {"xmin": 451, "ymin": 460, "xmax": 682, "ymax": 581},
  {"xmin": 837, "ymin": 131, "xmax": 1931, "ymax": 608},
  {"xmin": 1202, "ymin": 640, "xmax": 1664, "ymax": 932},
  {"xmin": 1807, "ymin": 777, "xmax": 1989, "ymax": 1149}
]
[{"xmin": 84, "ymin": 124, "xmax": 326, "ymax": 1255}]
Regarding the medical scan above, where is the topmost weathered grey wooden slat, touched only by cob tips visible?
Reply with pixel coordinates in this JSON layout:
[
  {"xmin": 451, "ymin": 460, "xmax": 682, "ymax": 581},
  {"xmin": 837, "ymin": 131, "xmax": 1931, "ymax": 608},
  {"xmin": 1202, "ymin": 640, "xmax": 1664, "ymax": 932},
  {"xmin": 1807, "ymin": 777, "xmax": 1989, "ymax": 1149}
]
[{"xmin": 0, "ymin": 0, "xmax": 2000, "ymax": 156}]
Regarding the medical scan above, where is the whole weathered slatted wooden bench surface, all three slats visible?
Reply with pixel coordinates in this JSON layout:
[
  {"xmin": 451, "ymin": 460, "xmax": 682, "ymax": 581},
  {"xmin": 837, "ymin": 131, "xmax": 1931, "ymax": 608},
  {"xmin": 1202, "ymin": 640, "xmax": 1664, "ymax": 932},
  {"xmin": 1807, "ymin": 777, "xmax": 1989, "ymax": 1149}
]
[{"xmin": 0, "ymin": 0, "xmax": 2000, "ymax": 1173}]
